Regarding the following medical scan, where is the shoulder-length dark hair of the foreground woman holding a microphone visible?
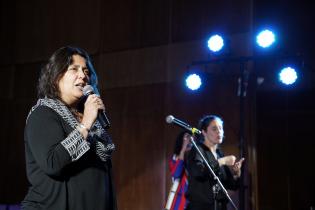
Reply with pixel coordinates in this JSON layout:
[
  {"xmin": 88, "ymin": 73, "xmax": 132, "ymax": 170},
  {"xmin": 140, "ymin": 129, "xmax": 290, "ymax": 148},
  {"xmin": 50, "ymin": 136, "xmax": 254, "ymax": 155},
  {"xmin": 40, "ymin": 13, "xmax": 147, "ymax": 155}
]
[{"xmin": 37, "ymin": 46, "xmax": 99, "ymax": 99}]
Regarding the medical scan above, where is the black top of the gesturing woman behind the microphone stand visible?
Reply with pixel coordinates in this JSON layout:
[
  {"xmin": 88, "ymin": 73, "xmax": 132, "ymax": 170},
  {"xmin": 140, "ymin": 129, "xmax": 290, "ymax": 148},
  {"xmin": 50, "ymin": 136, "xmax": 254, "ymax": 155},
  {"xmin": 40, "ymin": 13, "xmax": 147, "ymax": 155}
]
[{"xmin": 186, "ymin": 143, "xmax": 239, "ymax": 210}]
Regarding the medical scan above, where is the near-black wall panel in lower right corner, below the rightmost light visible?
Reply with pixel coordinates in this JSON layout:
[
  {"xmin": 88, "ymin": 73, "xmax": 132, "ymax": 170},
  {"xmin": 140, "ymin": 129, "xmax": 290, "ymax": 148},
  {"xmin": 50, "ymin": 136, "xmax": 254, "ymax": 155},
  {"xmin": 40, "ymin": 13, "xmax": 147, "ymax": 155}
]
[{"xmin": 257, "ymin": 89, "xmax": 315, "ymax": 210}]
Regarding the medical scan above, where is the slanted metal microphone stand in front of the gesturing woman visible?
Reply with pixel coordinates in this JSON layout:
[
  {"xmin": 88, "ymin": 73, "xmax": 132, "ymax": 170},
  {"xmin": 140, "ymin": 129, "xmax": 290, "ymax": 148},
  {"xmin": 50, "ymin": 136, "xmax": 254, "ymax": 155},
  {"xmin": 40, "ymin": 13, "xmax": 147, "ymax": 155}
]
[{"xmin": 190, "ymin": 135, "xmax": 238, "ymax": 210}]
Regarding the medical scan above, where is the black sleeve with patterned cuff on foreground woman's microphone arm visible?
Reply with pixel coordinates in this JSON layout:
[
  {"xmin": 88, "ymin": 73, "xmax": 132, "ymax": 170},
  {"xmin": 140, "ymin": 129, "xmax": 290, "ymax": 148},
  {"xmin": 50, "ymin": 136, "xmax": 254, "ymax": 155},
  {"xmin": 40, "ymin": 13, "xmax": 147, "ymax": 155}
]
[{"xmin": 25, "ymin": 106, "xmax": 89, "ymax": 176}]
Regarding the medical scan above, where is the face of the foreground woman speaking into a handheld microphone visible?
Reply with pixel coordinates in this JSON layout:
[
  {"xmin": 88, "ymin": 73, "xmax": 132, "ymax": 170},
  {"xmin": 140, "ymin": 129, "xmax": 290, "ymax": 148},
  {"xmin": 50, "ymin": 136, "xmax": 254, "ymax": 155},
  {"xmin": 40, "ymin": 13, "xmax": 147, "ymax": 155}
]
[{"xmin": 58, "ymin": 55, "xmax": 90, "ymax": 105}]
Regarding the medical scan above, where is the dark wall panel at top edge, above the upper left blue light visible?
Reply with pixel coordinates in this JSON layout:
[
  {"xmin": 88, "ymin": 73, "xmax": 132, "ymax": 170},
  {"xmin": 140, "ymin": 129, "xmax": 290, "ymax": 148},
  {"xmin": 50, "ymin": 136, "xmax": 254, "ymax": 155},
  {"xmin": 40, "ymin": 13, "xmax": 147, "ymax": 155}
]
[{"xmin": 172, "ymin": 0, "xmax": 252, "ymax": 42}]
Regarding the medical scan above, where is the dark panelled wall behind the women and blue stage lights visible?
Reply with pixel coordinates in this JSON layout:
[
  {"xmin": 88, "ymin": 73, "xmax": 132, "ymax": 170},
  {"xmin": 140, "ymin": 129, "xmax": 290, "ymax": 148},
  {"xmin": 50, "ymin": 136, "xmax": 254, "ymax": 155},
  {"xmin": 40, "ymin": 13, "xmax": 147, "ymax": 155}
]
[{"xmin": 0, "ymin": 0, "xmax": 315, "ymax": 210}]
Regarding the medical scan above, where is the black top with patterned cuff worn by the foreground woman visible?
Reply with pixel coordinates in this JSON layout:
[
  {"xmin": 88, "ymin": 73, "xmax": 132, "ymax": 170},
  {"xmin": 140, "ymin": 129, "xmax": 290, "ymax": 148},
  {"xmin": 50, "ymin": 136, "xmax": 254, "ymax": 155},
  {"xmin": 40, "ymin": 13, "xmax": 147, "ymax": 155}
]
[{"xmin": 22, "ymin": 99, "xmax": 116, "ymax": 210}]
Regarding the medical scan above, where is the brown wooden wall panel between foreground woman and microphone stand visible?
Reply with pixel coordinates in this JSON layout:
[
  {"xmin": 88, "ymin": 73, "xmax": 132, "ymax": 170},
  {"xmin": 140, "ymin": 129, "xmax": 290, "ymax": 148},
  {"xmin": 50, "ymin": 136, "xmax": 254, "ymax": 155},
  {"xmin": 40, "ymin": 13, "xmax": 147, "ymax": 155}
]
[{"xmin": 106, "ymin": 84, "xmax": 166, "ymax": 210}]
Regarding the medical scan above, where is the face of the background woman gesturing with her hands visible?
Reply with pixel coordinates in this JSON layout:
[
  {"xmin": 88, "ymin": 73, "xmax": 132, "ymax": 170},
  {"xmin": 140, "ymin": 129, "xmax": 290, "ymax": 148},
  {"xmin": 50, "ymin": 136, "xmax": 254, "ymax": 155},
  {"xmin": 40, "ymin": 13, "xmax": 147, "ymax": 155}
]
[{"xmin": 202, "ymin": 120, "xmax": 224, "ymax": 145}]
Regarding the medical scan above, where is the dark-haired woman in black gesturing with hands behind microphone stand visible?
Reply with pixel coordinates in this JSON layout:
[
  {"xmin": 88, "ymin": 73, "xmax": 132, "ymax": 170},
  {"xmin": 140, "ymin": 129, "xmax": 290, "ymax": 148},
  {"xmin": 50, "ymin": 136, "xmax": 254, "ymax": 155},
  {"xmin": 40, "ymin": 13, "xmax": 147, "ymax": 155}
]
[{"xmin": 187, "ymin": 115, "xmax": 244, "ymax": 210}]
